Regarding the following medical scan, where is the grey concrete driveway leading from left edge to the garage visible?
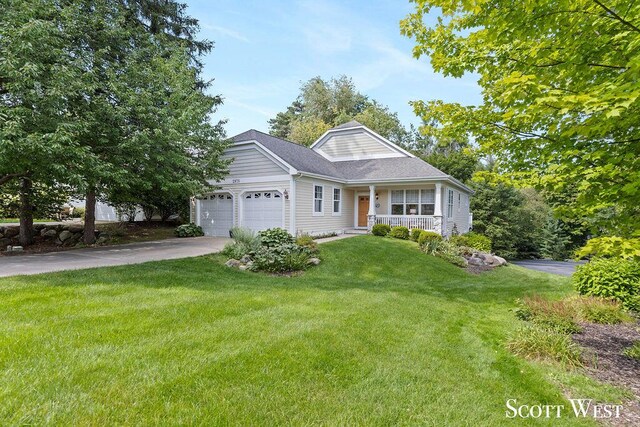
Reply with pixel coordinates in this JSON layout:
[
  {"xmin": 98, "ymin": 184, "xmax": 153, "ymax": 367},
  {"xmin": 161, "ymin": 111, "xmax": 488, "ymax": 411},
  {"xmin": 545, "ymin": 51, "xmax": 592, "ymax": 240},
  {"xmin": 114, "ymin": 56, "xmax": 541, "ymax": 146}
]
[{"xmin": 0, "ymin": 237, "xmax": 230, "ymax": 277}]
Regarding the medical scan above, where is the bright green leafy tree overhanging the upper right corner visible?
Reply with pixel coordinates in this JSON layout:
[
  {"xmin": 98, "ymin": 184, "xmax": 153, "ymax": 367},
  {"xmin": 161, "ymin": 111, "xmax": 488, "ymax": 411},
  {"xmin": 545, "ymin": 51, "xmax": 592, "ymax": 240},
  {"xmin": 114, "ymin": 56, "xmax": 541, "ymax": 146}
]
[{"xmin": 401, "ymin": 0, "xmax": 640, "ymax": 235}]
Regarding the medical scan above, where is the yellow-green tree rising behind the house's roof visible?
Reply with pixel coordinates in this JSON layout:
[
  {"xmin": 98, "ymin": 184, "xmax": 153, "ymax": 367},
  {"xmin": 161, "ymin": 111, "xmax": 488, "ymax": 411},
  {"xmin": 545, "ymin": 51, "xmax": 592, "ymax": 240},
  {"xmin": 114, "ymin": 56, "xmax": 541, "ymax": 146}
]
[{"xmin": 269, "ymin": 76, "xmax": 412, "ymax": 146}]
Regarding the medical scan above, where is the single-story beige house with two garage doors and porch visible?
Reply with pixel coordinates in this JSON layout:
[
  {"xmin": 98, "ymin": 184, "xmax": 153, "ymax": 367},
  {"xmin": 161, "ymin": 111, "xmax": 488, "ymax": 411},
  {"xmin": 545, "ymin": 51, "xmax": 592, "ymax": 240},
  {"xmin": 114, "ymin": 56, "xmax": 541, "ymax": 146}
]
[{"xmin": 191, "ymin": 121, "xmax": 473, "ymax": 236}]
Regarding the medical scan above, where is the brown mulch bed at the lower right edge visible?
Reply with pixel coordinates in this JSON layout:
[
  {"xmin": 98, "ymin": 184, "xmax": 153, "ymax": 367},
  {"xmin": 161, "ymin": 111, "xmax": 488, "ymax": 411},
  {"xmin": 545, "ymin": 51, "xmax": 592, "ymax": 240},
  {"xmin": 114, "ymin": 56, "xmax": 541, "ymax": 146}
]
[{"xmin": 573, "ymin": 322, "xmax": 640, "ymax": 426}]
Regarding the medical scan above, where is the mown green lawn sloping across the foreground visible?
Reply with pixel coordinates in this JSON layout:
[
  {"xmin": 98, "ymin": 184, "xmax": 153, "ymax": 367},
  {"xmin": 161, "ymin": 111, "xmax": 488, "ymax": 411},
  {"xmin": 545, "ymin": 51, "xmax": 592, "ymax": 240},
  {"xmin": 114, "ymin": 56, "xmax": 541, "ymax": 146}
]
[{"xmin": 0, "ymin": 236, "xmax": 621, "ymax": 426}]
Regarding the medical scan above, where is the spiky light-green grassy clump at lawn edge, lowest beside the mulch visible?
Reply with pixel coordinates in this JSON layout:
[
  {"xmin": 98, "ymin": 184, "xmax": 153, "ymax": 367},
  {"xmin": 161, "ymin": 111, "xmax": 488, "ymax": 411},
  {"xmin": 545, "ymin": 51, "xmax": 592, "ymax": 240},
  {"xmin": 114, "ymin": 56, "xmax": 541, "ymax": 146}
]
[{"xmin": 507, "ymin": 326, "xmax": 582, "ymax": 366}]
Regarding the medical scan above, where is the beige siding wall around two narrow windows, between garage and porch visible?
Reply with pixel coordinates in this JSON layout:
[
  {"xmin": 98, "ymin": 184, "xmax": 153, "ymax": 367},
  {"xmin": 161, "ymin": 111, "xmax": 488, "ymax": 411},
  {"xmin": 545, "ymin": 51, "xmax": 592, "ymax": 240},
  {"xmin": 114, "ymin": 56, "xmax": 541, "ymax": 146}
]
[{"xmin": 295, "ymin": 177, "xmax": 354, "ymax": 234}]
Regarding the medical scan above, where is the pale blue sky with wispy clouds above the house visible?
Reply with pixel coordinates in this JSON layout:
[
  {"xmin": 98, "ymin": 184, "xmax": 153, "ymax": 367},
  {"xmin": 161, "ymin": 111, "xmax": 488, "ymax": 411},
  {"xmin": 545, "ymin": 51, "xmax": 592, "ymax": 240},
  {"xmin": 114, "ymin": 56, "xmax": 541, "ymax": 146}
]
[{"xmin": 186, "ymin": 0, "xmax": 480, "ymax": 136}]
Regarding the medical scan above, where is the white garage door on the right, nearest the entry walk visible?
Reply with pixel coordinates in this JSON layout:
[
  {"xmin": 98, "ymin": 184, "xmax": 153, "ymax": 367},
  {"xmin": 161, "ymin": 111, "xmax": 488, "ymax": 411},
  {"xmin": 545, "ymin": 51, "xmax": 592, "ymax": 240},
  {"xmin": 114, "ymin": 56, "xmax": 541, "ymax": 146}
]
[{"xmin": 242, "ymin": 190, "xmax": 284, "ymax": 231}]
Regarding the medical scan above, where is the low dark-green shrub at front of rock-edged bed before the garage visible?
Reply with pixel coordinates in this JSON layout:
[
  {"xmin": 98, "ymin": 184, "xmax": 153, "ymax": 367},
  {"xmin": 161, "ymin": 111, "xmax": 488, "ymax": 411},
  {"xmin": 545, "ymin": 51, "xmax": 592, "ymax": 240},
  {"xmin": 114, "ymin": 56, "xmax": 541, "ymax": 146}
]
[{"xmin": 252, "ymin": 243, "xmax": 310, "ymax": 273}]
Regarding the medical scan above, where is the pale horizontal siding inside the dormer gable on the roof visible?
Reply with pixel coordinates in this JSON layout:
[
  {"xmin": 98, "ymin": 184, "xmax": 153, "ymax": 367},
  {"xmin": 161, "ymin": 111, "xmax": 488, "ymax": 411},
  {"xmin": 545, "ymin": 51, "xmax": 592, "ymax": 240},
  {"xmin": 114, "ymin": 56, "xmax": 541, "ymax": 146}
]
[{"xmin": 318, "ymin": 131, "xmax": 398, "ymax": 160}]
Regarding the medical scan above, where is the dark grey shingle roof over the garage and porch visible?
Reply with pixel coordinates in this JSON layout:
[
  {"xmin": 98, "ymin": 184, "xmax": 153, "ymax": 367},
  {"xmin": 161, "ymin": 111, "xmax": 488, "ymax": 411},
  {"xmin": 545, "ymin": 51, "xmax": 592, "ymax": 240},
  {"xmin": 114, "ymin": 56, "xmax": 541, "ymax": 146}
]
[{"xmin": 231, "ymin": 129, "xmax": 464, "ymax": 189}]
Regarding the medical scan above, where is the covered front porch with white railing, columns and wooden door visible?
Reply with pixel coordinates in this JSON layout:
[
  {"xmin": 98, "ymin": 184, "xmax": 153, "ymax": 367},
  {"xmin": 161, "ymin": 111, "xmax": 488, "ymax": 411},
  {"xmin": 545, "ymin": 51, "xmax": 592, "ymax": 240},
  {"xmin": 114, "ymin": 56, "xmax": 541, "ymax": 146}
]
[{"xmin": 344, "ymin": 182, "xmax": 445, "ymax": 234}]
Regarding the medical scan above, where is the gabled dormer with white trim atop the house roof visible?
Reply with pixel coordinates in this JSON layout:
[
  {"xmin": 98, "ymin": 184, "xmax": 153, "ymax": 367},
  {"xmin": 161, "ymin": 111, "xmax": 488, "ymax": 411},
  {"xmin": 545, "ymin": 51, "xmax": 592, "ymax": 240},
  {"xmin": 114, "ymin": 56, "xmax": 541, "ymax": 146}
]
[{"xmin": 311, "ymin": 120, "xmax": 415, "ymax": 162}]
